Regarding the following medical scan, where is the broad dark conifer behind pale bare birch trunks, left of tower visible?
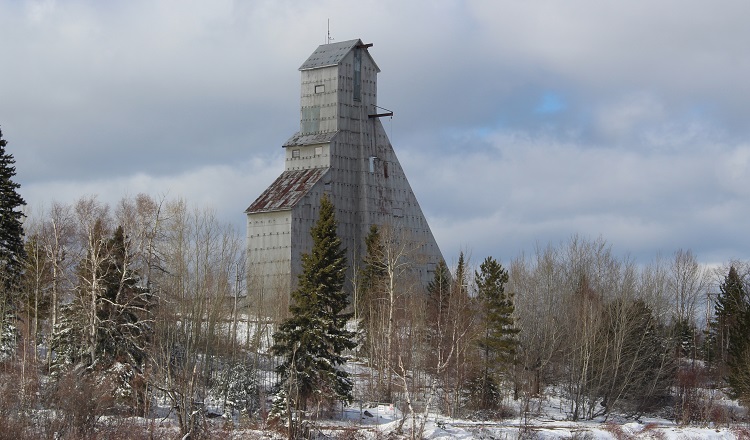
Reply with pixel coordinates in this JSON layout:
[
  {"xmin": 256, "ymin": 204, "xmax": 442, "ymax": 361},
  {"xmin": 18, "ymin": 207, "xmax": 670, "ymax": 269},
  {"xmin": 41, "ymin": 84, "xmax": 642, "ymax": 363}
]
[{"xmin": 52, "ymin": 225, "xmax": 153, "ymax": 407}]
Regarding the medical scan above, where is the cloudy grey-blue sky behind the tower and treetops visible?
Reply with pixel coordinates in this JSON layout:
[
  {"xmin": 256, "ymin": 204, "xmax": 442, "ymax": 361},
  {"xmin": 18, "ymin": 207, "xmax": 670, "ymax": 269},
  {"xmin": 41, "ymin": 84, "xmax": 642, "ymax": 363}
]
[{"xmin": 0, "ymin": 0, "xmax": 750, "ymax": 264}]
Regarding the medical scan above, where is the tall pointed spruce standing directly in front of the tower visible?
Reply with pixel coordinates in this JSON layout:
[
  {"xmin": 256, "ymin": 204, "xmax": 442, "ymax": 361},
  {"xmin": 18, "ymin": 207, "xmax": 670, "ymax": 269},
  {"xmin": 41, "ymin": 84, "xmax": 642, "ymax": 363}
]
[{"xmin": 271, "ymin": 195, "xmax": 356, "ymax": 428}]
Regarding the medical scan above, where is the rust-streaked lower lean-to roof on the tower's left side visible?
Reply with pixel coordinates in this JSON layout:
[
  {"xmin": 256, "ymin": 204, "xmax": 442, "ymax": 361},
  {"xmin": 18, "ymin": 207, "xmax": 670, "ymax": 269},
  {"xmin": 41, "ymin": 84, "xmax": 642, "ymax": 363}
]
[{"xmin": 245, "ymin": 168, "xmax": 328, "ymax": 214}]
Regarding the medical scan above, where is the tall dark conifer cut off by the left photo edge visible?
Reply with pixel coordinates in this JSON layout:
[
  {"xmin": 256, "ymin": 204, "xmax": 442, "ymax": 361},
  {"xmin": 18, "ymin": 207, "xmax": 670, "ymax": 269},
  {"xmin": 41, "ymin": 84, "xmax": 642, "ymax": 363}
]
[{"xmin": 0, "ymin": 130, "xmax": 26, "ymax": 356}]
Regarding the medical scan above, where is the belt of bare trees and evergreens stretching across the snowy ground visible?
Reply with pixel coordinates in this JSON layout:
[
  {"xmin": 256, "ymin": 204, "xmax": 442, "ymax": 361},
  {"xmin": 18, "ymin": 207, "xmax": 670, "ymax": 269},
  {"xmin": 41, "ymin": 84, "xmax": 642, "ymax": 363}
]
[{"xmin": 0, "ymin": 129, "xmax": 750, "ymax": 439}]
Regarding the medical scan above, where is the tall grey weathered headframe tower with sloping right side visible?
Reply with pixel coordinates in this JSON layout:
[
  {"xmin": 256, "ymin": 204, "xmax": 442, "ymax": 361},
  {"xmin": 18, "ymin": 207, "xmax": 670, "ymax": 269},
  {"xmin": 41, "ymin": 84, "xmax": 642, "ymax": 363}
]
[{"xmin": 245, "ymin": 40, "xmax": 442, "ymax": 307}]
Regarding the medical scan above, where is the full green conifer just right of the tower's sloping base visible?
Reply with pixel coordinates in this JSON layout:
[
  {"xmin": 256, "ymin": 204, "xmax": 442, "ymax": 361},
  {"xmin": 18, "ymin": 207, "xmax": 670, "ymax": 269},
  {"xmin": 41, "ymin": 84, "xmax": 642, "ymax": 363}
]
[{"xmin": 475, "ymin": 257, "xmax": 519, "ymax": 408}]
